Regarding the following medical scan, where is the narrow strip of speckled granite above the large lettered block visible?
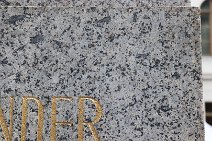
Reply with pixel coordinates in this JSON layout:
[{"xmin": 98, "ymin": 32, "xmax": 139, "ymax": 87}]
[{"xmin": 0, "ymin": 0, "xmax": 190, "ymax": 8}]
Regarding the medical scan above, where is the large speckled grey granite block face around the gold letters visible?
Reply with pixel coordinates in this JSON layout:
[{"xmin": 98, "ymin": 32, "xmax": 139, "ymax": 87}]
[{"xmin": 0, "ymin": 7, "xmax": 204, "ymax": 141}]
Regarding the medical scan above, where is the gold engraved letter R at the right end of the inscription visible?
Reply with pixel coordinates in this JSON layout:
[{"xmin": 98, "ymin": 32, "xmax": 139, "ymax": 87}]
[{"xmin": 78, "ymin": 97, "xmax": 103, "ymax": 141}]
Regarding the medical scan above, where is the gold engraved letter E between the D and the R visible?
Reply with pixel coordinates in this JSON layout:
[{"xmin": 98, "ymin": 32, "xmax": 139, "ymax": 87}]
[{"xmin": 50, "ymin": 97, "xmax": 73, "ymax": 141}]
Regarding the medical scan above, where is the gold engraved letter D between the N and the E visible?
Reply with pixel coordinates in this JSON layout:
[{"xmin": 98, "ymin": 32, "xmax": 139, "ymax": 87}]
[{"xmin": 21, "ymin": 96, "xmax": 44, "ymax": 141}]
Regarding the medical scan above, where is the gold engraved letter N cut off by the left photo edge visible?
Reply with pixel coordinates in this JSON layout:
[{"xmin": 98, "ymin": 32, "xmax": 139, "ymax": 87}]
[{"xmin": 0, "ymin": 97, "xmax": 14, "ymax": 141}]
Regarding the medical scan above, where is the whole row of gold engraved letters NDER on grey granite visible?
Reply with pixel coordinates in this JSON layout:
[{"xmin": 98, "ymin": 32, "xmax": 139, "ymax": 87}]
[{"xmin": 0, "ymin": 96, "xmax": 103, "ymax": 141}]
